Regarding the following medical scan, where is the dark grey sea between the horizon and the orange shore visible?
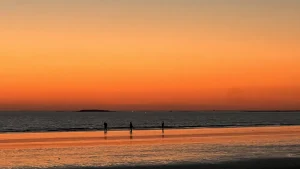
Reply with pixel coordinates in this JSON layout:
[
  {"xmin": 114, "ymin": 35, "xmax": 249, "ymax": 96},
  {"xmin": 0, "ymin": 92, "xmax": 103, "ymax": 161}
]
[{"xmin": 0, "ymin": 111, "xmax": 300, "ymax": 132}]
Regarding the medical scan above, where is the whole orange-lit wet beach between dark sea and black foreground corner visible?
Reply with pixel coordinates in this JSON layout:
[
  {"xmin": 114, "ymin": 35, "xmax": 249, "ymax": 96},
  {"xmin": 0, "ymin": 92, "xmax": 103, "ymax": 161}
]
[{"xmin": 0, "ymin": 127, "xmax": 300, "ymax": 168}]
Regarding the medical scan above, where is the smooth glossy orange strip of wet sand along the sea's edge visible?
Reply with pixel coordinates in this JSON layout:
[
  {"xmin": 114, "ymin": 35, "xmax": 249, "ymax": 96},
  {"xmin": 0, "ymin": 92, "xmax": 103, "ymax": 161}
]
[{"xmin": 0, "ymin": 126, "xmax": 300, "ymax": 149}]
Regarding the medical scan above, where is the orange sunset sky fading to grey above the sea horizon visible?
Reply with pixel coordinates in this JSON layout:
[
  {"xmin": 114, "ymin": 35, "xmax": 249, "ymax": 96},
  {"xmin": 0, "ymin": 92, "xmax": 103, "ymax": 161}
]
[{"xmin": 0, "ymin": 0, "xmax": 300, "ymax": 110}]
